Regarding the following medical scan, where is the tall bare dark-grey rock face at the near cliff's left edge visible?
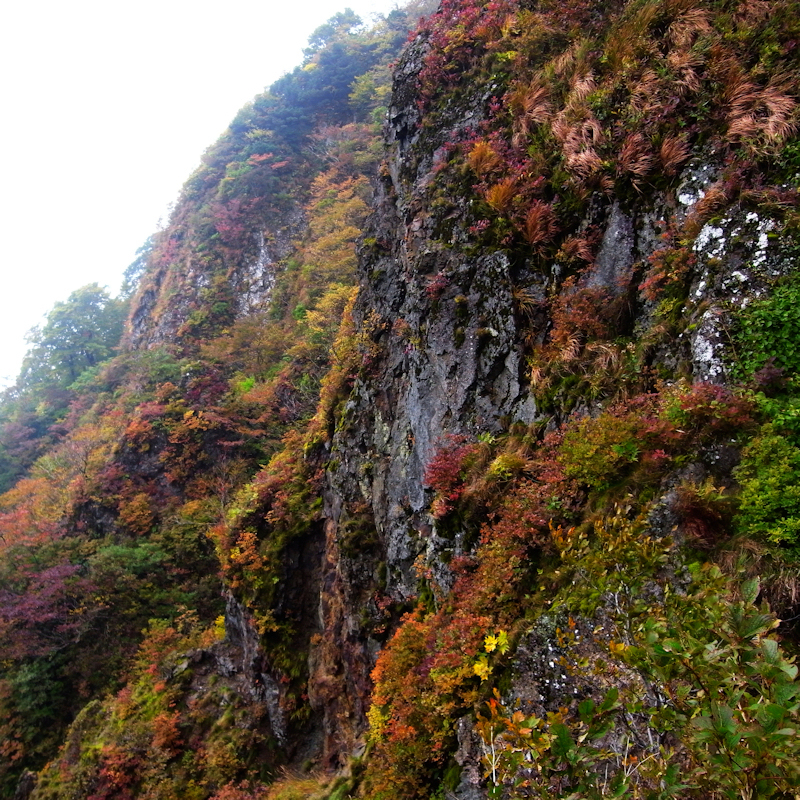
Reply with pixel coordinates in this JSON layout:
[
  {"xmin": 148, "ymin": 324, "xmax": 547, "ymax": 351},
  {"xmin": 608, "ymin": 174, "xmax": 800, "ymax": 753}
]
[{"xmin": 311, "ymin": 41, "xmax": 548, "ymax": 763}]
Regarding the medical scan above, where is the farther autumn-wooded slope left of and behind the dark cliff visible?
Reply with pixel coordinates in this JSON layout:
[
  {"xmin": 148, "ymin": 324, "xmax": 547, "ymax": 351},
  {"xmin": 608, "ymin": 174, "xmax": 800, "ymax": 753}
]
[{"xmin": 0, "ymin": 4, "xmax": 428, "ymax": 796}]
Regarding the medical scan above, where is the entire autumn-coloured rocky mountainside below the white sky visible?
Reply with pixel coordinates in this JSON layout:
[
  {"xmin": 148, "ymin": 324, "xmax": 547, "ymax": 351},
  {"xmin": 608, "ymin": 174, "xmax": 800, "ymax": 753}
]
[{"xmin": 0, "ymin": 0, "xmax": 800, "ymax": 800}]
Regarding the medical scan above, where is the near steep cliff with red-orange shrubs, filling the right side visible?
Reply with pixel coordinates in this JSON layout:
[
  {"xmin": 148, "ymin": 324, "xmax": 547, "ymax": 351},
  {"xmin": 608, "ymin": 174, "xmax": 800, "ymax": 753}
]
[{"xmin": 314, "ymin": 3, "xmax": 797, "ymax": 797}]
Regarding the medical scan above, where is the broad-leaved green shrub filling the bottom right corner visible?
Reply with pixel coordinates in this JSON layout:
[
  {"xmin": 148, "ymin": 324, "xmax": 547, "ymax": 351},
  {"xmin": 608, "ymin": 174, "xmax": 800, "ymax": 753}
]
[{"xmin": 625, "ymin": 567, "xmax": 800, "ymax": 798}]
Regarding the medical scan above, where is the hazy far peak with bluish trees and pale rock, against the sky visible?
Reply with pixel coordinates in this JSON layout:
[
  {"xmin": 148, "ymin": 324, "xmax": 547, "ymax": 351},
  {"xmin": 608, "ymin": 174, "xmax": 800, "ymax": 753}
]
[{"xmin": 128, "ymin": 10, "xmax": 413, "ymax": 349}]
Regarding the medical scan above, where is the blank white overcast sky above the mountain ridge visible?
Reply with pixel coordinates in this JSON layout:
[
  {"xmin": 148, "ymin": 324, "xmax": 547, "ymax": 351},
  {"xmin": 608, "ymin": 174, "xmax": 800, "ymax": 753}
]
[{"xmin": 0, "ymin": 0, "xmax": 397, "ymax": 385}]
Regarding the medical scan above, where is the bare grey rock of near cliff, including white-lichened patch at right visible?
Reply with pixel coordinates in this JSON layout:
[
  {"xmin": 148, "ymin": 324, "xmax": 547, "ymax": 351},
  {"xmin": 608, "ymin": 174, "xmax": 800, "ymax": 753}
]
[{"xmin": 304, "ymin": 26, "xmax": 788, "ymax": 776}]
